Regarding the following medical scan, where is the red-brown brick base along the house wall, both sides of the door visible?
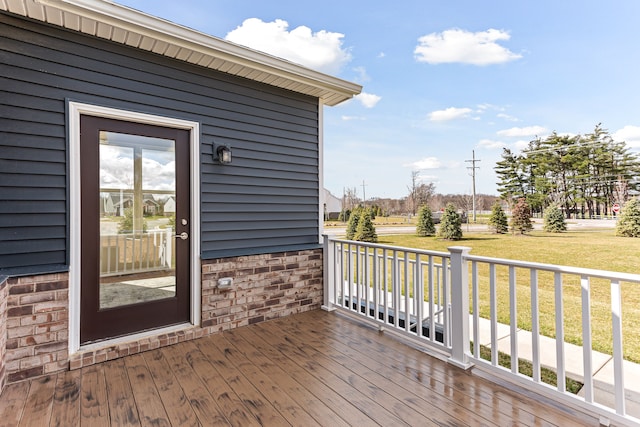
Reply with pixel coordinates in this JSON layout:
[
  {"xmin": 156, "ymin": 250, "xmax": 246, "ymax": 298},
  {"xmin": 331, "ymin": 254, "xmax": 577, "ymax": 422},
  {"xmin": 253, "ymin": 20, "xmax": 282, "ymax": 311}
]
[{"xmin": 0, "ymin": 249, "xmax": 323, "ymax": 392}]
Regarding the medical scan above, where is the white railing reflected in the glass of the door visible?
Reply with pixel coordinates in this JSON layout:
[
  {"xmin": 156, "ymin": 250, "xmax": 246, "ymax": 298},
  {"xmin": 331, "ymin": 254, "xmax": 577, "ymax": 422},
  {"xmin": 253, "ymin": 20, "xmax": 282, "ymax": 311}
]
[{"xmin": 100, "ymin": 228, "xmax": 173, "ymax": 277}]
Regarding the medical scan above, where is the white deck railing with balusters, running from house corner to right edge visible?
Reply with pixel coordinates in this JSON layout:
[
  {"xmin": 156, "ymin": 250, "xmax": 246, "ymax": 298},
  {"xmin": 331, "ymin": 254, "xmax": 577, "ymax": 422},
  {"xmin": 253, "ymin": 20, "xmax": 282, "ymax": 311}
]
[{"xmin": 323, "ymin": 236, "xmax": 640, "ymax": 425}]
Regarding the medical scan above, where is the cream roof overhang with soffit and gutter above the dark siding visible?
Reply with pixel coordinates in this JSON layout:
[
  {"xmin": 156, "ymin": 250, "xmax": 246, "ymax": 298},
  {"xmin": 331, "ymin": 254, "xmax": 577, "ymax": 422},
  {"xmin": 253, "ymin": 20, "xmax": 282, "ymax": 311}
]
[{"xmin": 0, "ymin": 0, "xmax": 362, "ymax": 106}]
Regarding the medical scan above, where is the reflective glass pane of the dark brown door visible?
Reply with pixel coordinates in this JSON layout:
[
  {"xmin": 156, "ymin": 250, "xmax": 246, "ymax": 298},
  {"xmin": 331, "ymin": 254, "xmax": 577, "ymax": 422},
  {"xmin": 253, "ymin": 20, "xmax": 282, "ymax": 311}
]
[{"xmin": 99, "ymin": 131, "xmax": 176, "ymax": 309}]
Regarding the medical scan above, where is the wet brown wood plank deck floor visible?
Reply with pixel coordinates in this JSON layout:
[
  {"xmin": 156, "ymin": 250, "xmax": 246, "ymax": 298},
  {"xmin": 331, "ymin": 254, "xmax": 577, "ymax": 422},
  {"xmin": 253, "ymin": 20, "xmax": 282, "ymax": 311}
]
[{"xmin": 0, "ymin": 311, "xmax": 598, "ymax": 427}]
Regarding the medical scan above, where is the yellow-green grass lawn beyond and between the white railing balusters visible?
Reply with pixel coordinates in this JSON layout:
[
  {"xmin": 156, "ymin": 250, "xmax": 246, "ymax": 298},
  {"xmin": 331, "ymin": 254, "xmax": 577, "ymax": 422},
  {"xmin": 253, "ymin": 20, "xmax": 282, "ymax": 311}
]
[{"xmin": 379, "ymin": 229, "xmax": 640, "ymax": 363}]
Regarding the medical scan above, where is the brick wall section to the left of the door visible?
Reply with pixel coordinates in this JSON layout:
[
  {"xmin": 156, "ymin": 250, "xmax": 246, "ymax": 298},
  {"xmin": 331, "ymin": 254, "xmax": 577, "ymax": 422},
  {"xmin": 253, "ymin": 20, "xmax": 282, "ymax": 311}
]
[{"xmin": 5, "ymin": 273, "xmax": 69, "ymax": 382}]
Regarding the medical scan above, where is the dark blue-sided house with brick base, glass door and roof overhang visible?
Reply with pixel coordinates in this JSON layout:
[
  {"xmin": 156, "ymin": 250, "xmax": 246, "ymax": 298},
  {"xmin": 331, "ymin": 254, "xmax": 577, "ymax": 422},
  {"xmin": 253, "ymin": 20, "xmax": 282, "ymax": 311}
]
[{"xmin": 0, "ymin": 0, "xmax": 361, "ymax": 390}]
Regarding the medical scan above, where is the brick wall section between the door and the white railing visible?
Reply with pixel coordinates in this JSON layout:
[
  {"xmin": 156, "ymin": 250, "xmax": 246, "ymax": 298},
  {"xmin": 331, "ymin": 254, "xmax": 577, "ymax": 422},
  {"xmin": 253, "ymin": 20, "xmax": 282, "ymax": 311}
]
[{"xmin": 202, "ymin": 249, "xmax": 322, "ymax": 333}]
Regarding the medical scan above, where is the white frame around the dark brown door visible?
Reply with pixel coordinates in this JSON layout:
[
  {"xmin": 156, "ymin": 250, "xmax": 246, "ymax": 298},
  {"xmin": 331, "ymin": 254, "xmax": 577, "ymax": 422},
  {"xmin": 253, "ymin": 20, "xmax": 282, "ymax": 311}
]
[{"xmin": 67, "ymin": 100, "xmax": 201, "ymax": 354}]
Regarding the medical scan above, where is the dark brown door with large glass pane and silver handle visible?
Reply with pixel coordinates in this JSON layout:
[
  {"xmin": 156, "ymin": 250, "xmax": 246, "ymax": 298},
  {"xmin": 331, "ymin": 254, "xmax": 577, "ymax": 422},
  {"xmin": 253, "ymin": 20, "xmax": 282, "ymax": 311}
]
[{"xmin": 80, "ymin": 115, "xmax": 191, "ymax": 344}]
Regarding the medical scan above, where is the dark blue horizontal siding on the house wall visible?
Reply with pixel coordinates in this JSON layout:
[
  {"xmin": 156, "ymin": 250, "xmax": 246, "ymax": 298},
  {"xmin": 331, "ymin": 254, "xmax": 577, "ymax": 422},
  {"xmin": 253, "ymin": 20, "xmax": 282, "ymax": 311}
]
[{"xmin": 0, "ymin": 14, "xmax": 319, "ymax": 271}]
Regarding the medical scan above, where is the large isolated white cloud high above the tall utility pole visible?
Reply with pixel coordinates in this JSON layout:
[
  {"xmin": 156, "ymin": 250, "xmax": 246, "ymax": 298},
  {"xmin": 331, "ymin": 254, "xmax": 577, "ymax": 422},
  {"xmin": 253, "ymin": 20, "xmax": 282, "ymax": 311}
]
[{"xmin": 413, "ymin": 28, "xmax": 522, "ymax": 65}]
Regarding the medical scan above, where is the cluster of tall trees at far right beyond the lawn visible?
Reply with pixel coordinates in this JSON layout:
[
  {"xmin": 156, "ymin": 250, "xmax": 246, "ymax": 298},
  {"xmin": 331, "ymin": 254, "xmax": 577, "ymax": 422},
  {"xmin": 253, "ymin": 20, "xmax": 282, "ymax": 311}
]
[{"xmin": 495, "ymin": 124, "xmax": 640, "ymax": 218}]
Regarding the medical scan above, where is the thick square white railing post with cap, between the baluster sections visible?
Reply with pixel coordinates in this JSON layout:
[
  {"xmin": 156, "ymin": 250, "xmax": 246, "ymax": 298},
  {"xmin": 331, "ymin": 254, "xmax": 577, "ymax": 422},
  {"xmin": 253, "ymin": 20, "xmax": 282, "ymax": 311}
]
[{"xmin": 445, "ymin": 246, "xmax": 473, "ymax": 369}]
